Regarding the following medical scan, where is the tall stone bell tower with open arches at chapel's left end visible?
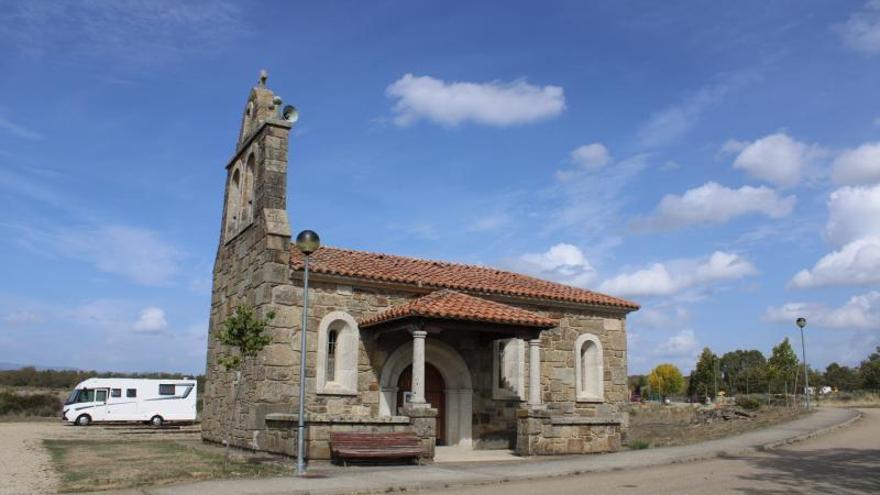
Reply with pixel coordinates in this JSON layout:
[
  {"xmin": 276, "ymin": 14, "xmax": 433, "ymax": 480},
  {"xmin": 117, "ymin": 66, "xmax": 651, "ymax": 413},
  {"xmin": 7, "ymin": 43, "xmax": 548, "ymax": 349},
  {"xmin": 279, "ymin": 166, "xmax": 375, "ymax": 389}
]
[{"xmin": 202, "ymin": 71, "xmax": 298, "ymax": 448}]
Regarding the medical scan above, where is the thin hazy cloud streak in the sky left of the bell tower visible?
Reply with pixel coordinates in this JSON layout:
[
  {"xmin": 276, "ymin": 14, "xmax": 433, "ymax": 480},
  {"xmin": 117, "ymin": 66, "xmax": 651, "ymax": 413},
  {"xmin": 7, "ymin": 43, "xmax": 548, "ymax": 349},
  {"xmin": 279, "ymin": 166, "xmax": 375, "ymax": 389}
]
[{"xmin": 37, "ymin": 225, "xmax": 182, "ymax": 285}]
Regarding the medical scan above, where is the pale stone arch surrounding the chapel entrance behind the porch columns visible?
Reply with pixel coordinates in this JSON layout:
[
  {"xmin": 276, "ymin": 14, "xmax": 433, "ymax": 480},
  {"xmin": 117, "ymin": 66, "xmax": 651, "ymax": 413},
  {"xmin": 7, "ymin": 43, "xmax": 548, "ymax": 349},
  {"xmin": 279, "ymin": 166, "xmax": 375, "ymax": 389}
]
[{"xmin": 379, "ymin": 338, "xmax": 474, "ymax": 447}]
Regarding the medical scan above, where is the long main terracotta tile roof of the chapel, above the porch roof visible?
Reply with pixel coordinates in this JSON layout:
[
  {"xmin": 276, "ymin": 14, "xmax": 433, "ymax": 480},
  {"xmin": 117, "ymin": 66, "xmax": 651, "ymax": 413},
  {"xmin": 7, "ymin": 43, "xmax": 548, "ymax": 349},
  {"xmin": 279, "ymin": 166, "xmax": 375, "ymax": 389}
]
[{"xmin": 290, "ymin": 245, "xmax": 639, "ymax": 311}]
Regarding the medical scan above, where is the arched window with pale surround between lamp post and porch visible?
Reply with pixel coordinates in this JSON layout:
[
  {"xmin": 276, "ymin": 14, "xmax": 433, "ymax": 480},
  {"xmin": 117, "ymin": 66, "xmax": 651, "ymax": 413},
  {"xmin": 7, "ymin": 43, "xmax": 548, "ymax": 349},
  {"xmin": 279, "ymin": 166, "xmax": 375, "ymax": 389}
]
[{"xmin": 316, "ymin": 311, "xmax": 360, "ymax": 395}]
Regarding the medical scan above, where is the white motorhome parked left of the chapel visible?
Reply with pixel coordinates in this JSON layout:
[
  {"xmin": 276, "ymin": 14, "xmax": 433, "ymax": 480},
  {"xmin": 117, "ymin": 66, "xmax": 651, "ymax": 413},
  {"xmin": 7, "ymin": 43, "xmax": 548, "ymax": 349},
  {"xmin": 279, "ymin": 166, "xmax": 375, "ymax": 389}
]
[{"xmin": 61, "ymin": 378, "xmax": 197, "ymax": 426}]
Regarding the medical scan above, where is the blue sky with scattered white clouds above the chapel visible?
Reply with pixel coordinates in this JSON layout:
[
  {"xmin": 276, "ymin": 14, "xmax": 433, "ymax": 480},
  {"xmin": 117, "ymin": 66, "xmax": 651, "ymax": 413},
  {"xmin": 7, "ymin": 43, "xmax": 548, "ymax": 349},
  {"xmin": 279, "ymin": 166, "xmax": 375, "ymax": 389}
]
[{"xmin": 0, "ymin": 0, "xmax": 880, "ymax": 372}]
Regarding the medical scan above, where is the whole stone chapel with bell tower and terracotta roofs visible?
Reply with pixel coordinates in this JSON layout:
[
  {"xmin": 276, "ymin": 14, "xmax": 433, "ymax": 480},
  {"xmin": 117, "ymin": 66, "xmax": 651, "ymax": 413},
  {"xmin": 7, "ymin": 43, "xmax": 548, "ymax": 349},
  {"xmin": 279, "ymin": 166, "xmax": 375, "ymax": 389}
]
[{"xmin": 202, "ymin": 73, "xmax": 638, "ymax": 459}]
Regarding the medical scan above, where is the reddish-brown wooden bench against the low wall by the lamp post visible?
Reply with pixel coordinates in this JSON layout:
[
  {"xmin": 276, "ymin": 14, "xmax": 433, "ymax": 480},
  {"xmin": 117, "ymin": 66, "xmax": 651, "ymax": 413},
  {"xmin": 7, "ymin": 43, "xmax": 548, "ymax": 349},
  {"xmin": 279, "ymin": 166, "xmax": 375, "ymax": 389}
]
[{"xmin": 330, "ymin": 432, "xmax": 424, "ymax": 465}]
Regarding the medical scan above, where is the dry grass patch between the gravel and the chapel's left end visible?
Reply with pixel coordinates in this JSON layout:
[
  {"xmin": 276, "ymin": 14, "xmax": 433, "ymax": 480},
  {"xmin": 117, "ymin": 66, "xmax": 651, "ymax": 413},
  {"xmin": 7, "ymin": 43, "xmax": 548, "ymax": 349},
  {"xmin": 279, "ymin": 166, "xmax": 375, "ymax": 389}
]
[{"xmin": 43, "ymin": 440, "xmax": 291, "ymax": 492}]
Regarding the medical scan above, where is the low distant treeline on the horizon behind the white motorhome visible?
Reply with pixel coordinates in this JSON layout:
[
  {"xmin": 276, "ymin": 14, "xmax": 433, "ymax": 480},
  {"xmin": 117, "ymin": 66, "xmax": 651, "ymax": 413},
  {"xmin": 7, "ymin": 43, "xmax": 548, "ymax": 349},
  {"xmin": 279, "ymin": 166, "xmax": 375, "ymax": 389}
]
[{"xmin": 0, "ymin": 366, "xmax": 205, "ymax": 392}]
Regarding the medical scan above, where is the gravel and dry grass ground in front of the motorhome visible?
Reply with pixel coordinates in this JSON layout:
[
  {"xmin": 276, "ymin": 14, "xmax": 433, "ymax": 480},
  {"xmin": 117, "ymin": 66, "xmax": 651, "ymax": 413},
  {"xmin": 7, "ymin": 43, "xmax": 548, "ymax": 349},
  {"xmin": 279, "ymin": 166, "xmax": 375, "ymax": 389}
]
[{"xmin": 0, "ymin": 421, "xmax": 291, "ymax": 495}]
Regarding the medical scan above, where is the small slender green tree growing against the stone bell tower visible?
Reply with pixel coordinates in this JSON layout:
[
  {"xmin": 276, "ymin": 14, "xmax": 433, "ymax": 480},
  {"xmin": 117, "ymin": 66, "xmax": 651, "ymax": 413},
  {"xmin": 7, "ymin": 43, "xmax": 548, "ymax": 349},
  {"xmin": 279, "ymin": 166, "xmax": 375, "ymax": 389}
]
[{"xmin": 217, "ymin": 304, "xmax": 275, "ymax": 467}]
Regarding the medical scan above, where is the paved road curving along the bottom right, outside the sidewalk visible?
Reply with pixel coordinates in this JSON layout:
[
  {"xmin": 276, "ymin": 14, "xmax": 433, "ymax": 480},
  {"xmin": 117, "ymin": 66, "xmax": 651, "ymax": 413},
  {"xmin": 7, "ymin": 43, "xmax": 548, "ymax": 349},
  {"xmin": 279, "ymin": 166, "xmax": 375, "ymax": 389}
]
[{"xmin": 420, "ymin": 409, "xmax": 880, "ymax": 495}]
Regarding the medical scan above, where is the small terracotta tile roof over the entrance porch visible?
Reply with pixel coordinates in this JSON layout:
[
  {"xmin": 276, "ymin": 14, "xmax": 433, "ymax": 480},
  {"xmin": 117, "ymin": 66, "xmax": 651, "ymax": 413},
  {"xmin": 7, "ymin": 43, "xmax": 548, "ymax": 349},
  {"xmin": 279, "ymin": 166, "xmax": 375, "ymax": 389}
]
[{"xmin": 360, "ymin": 289, "xmax": 558, "ymax": 328}]
